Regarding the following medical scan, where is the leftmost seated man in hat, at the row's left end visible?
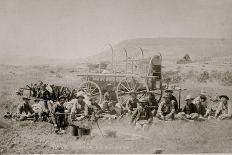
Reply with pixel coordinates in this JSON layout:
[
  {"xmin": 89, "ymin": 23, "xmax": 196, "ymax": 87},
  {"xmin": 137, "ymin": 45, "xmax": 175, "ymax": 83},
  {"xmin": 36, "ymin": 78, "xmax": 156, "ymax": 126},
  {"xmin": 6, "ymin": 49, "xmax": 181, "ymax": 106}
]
[{"xmin": 15, "ymin": 96, "xmax": 35, "ymax": 121}]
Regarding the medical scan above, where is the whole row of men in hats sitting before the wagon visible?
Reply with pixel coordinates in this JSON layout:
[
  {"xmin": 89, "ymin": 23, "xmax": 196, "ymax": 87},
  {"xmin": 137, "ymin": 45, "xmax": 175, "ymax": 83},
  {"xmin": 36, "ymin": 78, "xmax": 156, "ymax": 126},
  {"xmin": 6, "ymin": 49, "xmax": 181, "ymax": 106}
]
[{"xmin": 13, "ymin": 85, "xmax": 232, "ymax": 131}]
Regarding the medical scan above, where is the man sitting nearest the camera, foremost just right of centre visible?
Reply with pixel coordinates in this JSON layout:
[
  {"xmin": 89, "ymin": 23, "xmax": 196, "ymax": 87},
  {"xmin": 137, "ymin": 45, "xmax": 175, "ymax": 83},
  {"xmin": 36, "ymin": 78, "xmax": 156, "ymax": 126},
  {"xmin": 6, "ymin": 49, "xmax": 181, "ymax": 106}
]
[{"xmin": 131, "ymin": 99, "xmax": 153, "ymax": 129}]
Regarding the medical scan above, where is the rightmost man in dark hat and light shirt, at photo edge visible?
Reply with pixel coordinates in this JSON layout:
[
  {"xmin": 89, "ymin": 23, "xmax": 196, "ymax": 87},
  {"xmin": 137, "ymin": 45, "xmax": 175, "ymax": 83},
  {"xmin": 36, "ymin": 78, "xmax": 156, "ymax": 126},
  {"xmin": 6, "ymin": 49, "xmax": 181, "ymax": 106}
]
[{"xmin": 215, "ymin": 95, "xmax": 232, "ymax": 120}]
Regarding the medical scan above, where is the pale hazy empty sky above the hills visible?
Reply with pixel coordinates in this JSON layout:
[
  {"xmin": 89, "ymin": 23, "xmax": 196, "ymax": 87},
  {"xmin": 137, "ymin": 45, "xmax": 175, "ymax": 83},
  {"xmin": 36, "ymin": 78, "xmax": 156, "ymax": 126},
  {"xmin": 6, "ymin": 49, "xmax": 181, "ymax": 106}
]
[{"xmin": 0, "ymin": 0, "xmax": 232, "ymax": 59}]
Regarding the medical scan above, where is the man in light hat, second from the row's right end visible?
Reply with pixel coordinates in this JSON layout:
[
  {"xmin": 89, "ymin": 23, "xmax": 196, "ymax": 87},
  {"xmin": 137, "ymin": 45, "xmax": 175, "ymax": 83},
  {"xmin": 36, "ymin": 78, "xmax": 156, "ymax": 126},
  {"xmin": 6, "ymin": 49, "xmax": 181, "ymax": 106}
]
[{"xmin": 193, "ymin": 90, "xmax": 211, "ymax": 118}]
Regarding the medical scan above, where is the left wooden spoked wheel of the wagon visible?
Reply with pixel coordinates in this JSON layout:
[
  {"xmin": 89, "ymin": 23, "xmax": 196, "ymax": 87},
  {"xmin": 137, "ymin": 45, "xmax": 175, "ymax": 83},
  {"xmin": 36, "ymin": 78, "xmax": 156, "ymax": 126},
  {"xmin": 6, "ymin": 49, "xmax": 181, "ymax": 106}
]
[{"xmin": 78, "ymin": 81, "xmax": 102, "ymax": 104}]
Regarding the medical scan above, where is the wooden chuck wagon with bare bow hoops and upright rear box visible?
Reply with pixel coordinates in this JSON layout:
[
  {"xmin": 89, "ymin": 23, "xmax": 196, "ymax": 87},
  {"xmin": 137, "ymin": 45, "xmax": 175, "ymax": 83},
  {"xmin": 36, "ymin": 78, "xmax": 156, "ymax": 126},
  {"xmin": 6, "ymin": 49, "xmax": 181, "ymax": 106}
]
[{"xmin": 77, "ymin": 46, "xmax": 163, "ymax": 104}]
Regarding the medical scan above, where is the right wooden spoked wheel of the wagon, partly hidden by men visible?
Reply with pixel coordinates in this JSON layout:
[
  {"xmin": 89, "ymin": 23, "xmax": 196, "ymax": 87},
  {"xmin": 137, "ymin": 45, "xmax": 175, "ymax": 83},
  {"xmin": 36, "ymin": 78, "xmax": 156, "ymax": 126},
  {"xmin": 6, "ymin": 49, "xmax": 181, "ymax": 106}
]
[{"xmin": 116, "ymin": 77, "xmax": 148, "ymax": 105}]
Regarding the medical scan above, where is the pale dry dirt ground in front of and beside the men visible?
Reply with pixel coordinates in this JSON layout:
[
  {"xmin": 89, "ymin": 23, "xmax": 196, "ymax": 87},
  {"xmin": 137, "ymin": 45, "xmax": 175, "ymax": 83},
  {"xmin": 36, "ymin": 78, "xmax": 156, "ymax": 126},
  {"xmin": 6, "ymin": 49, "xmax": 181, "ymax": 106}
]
[{"xmin": 0, "ymin": 65, "xmax": 232, "ymax": 153}]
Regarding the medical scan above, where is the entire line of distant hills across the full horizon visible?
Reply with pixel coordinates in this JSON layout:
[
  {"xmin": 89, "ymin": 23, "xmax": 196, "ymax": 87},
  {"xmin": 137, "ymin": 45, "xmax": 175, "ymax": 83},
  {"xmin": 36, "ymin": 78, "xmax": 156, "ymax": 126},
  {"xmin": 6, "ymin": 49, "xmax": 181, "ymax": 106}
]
[{"xmin": 0, "ymin": 38, "xmax": 232, "ymax": 65}]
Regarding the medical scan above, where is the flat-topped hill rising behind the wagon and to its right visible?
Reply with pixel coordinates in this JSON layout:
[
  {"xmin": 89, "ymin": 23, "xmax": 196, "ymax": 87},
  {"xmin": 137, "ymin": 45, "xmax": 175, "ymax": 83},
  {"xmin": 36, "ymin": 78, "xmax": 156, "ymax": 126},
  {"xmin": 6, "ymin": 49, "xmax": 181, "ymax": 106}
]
[{"xmin": 85, "ymin": 38, "xmax": 232, "ymax": 62}]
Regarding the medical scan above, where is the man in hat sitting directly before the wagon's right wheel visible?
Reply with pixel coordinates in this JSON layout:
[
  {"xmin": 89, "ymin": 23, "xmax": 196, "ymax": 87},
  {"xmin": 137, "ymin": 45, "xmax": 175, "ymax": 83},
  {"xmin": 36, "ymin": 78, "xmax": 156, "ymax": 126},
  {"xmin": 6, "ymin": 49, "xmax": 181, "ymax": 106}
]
[{"xmin": 126, "ymin": 91, "xmax": 139, "ymax": 115}]
